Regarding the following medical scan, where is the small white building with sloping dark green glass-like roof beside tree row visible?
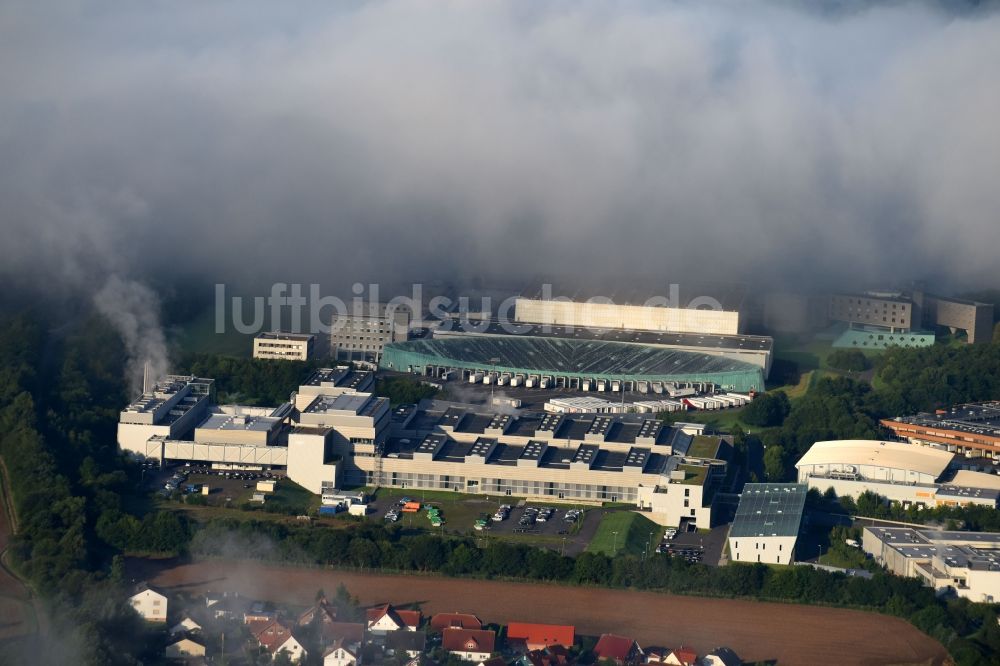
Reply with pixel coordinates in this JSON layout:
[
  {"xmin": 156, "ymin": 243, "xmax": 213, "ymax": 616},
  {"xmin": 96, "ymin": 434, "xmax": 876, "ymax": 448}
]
[{"xmin": 729, "ymin": 483, "xmax": 808, "ymax": 564}]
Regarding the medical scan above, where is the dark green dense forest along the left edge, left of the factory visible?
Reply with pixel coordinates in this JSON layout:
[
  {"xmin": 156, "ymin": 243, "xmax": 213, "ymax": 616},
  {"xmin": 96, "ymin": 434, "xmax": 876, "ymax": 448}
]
[{"xmin": 0, "ymin": 316, "xmax": 176, "ymax": 666}]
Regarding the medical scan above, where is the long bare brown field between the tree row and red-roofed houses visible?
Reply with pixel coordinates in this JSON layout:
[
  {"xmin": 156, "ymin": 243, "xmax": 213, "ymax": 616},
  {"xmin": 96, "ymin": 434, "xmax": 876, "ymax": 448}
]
[{"xmin": 129, "ymin": 560, "xmax": 947, "ymax": 666}]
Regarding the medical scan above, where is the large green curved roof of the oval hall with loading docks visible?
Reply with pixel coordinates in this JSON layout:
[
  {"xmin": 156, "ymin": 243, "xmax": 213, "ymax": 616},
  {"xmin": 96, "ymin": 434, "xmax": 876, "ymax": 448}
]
[{"xmin": 381, "ymin": 336, "xmax": 764, "ymax": 390}]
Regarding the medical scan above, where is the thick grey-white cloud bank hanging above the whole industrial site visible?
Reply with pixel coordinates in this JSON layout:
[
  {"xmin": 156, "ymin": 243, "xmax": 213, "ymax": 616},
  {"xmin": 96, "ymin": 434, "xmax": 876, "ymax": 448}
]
[{"xmin": 0, "ymin": 0, "xmax": 1000, "ymax": 296}]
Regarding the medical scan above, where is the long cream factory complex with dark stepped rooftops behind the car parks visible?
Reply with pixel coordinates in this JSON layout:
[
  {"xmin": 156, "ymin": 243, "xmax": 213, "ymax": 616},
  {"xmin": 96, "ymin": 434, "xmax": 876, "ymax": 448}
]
[{"xmin": 118, "ymin": 367, "xmax": 731, "ymax": 527}]
